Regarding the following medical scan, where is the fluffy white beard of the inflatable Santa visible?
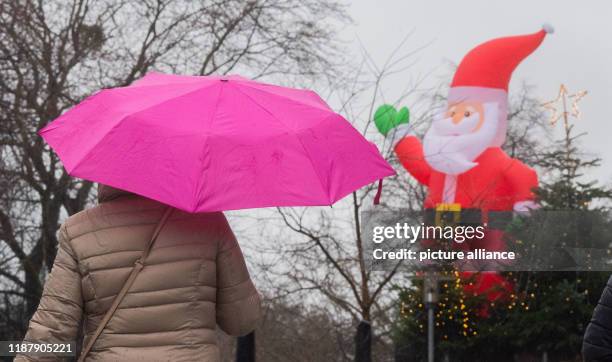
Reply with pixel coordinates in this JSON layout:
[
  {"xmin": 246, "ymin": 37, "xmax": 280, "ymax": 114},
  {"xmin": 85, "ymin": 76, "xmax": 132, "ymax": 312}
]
[{"xmin": 423, "ymin": 103, "xmax": 499, "ymax": 175}]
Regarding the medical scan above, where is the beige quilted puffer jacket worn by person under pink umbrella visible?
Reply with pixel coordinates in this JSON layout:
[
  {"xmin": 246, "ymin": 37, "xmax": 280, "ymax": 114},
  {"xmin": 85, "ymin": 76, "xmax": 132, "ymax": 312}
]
[{"xmin": 15, "ymin": 186, "xmax": 260, "ymax": 361}]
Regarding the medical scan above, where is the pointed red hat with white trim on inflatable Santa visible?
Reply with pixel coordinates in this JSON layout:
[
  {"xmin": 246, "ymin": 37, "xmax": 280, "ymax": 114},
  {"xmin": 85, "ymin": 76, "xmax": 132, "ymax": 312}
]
[{"xmin": 448, "ymin": 25, "xmax": 554, "ymax": 146}]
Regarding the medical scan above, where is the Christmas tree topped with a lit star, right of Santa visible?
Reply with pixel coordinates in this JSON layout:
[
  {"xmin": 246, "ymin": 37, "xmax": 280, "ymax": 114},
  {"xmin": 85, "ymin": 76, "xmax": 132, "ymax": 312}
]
[{"xmin": 506, "ymin": 90, "xmax": 612, "ymax": 360}]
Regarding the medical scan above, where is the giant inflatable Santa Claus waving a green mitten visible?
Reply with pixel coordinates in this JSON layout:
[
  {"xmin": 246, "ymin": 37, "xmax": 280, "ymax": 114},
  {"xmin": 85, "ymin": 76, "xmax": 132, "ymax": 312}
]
[{"xmin": 374, "ymin": 26, "xmax": 552, "ymax": 299}]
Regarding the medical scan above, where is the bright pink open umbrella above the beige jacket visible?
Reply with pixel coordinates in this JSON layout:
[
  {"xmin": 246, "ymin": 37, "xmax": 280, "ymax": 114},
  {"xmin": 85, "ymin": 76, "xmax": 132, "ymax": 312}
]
[{"xmin": 40, "ymin": 73, "xmax": 395, "ymax": 212}]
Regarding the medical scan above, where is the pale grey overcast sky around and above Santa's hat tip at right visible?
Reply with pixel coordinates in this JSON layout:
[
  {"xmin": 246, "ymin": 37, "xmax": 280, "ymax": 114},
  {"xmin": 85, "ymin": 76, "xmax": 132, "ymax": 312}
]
[{"xmin": 342, "ymin": 0, "xmax": 612, "ymax": 184}]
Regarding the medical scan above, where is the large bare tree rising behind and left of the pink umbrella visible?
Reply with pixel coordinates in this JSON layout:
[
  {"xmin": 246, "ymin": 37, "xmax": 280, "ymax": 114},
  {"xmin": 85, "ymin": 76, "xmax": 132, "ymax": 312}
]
[{"xmin": 0, "ymin": 0, "xmax": 346, "ymax": 331}]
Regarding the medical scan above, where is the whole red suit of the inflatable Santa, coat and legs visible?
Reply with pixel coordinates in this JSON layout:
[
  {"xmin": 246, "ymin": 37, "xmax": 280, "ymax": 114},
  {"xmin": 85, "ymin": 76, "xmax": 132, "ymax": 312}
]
[{"xmin": 395, "ymin": 136, "xmax": 538, "ymax": 304}]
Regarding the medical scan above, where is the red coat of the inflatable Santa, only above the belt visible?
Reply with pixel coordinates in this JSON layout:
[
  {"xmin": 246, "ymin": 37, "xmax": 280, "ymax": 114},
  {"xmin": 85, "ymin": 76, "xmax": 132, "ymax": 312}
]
[{"xmin": 395, "ymin": 136, "xmax": 538, "ymax": 211}]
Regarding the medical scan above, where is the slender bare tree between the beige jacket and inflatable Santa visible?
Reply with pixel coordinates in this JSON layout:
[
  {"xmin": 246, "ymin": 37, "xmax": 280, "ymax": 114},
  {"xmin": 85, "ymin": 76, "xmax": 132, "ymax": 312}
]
[{"xmin": 233, "ymin": 37, "xmax": 436, "ymax": 361}]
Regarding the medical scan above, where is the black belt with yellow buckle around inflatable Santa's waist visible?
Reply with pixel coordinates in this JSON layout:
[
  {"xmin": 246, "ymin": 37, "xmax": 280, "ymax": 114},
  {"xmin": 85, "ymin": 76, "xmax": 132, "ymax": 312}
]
[{"xmin": 425, "ymin": 208, "xmax": 513, "ymax": 229}]
